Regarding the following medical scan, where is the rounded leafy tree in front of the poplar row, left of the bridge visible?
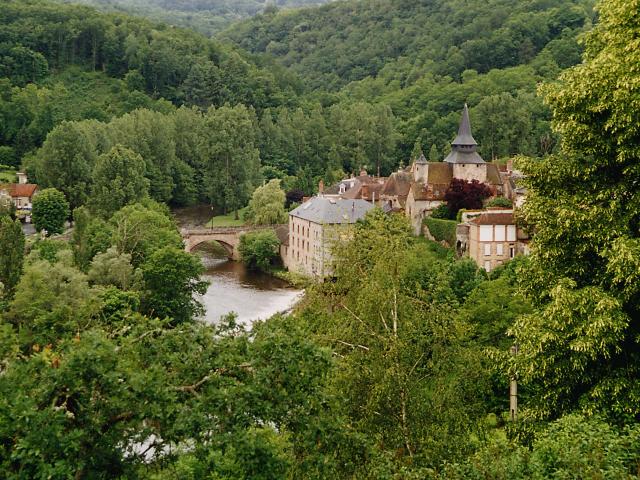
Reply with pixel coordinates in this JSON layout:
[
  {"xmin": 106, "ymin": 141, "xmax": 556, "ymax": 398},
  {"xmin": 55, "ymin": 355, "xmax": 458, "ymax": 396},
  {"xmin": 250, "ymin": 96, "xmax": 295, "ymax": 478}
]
[{"xmin": 89, "ymin": 145, "xmax": 149, "ymax": 218}]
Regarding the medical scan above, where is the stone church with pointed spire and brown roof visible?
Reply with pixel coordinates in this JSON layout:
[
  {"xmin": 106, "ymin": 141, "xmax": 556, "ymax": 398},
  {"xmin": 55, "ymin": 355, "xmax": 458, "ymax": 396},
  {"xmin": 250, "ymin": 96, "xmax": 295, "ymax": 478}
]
[{"xmin": 402, "ymin": 105, "xmax": 503, "ymax": 234}]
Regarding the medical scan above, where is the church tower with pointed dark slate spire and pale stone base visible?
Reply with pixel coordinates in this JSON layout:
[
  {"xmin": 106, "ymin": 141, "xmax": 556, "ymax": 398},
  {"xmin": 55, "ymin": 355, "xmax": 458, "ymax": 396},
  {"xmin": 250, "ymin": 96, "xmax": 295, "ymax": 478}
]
[{"xmin": 444, "ymin": 103, "xmax": 487, "ymax": 183}]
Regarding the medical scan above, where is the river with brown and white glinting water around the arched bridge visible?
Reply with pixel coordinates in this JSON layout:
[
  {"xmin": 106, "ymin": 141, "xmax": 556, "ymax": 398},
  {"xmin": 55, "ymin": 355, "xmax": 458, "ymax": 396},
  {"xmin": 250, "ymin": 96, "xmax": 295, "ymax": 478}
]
[{"xmin": 174, "ymin": 207, "xmax": 303, "ymax": 326}]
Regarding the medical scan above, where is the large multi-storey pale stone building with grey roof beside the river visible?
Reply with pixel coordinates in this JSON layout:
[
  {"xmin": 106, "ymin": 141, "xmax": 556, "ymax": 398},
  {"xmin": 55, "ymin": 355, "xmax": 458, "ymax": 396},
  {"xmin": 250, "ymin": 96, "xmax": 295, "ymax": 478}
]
[{"xmin": 284, "ymin": 194, "xmax": 374, "ymax": 278}]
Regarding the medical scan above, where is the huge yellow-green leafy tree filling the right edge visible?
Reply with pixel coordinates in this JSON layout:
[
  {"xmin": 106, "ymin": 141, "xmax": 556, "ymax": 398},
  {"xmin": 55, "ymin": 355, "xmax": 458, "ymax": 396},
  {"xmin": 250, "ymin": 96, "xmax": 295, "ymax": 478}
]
[{"xmin": 513, "ymin": 0, "xmax": 640, "ymax": 421}]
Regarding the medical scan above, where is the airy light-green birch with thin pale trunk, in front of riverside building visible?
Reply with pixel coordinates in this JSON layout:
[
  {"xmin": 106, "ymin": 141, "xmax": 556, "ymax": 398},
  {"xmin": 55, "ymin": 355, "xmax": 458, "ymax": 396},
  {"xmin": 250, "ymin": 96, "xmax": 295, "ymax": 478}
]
[{"xmin": 304, "ymin": 210, "xmax": 486, "ymax": 468}]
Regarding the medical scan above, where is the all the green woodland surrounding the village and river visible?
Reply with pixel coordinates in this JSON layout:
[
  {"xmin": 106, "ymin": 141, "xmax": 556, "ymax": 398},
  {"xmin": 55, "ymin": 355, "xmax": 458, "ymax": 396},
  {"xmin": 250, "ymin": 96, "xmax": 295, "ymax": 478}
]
[{"xmin": 0, "ymin": 0, "xmax": 640, "ymax": 480}]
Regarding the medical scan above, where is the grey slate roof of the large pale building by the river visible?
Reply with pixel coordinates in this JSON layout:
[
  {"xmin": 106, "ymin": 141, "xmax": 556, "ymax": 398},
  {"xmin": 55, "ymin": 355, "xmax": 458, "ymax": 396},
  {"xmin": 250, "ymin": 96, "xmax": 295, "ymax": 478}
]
[{"xmin": 289, "ymin": 197, "xmax": 374, "ymax": 224}]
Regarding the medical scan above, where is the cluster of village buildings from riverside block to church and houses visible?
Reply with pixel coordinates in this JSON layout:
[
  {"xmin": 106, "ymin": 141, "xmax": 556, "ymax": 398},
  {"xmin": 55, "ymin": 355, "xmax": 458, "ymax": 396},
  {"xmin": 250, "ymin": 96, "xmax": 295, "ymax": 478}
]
[{"xmin": 281, "ymin": 105, "xmax": 529, "ymax": 278}]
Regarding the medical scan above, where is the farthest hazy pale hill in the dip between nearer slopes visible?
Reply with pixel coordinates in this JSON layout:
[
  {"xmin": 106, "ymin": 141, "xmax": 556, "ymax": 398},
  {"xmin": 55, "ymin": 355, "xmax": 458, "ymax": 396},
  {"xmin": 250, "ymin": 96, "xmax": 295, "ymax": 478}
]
[{"xmin": 59, "ymin": 0, "xmax": 332, "ymax": 35}]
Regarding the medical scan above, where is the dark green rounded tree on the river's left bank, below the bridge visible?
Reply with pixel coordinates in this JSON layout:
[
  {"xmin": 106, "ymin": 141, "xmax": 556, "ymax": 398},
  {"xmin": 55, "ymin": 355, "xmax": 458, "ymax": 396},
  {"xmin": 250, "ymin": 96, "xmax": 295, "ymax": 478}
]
[{"xmin": 142, "ymin": 247, "xmax": 208, "ymax": 325}]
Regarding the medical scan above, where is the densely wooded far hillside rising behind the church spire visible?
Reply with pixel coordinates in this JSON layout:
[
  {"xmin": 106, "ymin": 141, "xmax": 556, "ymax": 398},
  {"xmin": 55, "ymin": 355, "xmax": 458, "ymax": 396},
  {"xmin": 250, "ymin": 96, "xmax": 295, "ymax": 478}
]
[{"xmin": 221, "ymin": 0, "xmax": 594, "ymax": 90}]
